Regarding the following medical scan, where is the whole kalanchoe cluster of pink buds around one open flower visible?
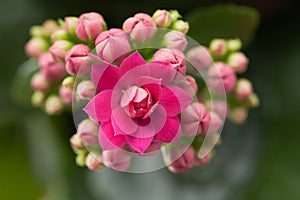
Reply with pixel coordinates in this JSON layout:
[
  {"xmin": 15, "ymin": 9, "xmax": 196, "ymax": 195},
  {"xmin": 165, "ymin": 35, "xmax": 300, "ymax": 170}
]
[{"xmin": 25, "ymin": 10, "xmax": 259, "ymax": 173}]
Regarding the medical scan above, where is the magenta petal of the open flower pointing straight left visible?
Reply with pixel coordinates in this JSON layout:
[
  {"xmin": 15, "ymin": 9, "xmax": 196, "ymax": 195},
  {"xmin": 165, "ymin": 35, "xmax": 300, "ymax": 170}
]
[{"xmin": 83, "ymin": 90, "xmax": 112, "ymax": 122}]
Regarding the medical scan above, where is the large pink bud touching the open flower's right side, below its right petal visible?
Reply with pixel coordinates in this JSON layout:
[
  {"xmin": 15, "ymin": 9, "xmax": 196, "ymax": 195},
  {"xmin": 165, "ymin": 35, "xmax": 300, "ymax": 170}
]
[{"xmin": 181, "ymin": 102, "xmax": 211, "ymax": 136}]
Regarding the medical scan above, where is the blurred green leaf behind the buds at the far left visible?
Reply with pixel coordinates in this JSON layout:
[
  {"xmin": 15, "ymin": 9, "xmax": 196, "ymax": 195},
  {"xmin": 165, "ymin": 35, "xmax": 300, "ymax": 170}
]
[{"xmin": 11, "ymin": 59, "xmax": 38, "ymax": 106}]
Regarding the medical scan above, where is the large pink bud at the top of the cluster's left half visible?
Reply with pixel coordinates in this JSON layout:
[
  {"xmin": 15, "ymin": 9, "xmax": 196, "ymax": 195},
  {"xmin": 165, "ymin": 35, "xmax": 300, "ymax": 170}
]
[{"xmin": 76, "ymin": 12, "xmax": 106, "ymax": 41}]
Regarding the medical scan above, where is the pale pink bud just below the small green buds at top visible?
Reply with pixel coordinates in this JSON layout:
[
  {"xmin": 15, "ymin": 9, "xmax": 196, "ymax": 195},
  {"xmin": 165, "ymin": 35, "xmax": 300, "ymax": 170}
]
[{"xmin": 164, "ymin": 31, "xmax": 187, "ymax": 51}]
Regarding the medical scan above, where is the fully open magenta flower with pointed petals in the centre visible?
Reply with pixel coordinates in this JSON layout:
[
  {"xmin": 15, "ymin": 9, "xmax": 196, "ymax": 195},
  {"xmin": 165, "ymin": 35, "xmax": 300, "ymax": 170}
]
[{"xmin": 84, "ymin": 52, "xmax": 192, "ymax": 154}]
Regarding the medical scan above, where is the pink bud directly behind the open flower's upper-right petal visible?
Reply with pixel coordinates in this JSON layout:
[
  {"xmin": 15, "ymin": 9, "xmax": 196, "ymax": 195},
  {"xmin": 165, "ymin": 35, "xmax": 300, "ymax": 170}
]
[{"xmin": 153, "ymin": 48, "xmax": 186, "ymax": 75}]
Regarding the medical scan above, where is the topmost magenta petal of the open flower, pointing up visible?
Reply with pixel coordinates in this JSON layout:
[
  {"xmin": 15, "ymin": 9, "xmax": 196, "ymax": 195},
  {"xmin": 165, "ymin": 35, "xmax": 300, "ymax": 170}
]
[{"xmin": 120, "ymin": 51, "xmax": 146, "ymax": 75}]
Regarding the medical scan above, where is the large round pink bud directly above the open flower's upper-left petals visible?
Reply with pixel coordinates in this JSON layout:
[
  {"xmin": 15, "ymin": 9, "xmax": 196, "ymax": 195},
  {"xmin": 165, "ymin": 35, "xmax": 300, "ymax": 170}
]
[{"xmin": 95, "ymin": 28, "xmax": 130, "ymax": 62}]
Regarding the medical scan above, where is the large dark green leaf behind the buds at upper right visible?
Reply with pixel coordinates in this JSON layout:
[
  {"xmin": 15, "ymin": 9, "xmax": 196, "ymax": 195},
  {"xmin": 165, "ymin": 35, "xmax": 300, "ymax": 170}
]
[{"xmin": 186, "ymin": 4, "xmax": 260, "ymax": 45}]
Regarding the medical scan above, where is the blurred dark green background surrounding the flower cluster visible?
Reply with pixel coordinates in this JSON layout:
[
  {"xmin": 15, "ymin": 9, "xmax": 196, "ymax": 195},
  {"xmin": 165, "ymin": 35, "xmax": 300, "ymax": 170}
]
[{"xmin": 0, "ymin": 0, "xmax": 300, "ymax": 200}]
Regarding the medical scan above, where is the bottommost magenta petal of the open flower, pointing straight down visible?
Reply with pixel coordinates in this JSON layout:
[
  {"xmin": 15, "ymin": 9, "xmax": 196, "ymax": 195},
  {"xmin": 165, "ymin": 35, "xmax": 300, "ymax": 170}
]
[{"xmin": 126, "ymin": 135, "xmax": 153, "ymax": 155}]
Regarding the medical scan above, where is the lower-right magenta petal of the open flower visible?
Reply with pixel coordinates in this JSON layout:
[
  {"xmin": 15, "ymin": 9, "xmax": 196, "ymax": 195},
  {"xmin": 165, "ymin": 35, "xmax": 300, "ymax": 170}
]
[{"xmin": 155, "ymin": 116, "xmax": 180, "ymax": 143}]
